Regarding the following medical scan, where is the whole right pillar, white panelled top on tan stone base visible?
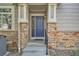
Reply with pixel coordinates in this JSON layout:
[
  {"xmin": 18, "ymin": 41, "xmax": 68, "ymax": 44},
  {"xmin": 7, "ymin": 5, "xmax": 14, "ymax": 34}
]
[{"xmin": 48, "ymin": 4, "xmax": 57, "ymax": 48}]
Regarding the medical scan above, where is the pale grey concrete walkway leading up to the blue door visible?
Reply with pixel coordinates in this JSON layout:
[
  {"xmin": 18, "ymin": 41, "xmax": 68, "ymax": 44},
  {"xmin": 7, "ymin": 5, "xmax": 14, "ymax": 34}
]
[{"xmin": 22, "ymin": 41, "xmax": 46, "ymax": 56}]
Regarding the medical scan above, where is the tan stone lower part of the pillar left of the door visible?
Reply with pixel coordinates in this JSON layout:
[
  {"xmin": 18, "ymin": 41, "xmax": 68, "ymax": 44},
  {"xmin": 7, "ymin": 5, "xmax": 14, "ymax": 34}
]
[{"xmin": 20, "ymin": 22, "xmax": 29, "ymax": 48}]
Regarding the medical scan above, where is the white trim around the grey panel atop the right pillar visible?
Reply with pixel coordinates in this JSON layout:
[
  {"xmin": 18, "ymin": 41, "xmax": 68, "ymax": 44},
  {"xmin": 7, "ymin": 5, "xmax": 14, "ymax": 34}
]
[{"xmin": 48, "ymin": 4, "xmax": 57, "ymax": 22}]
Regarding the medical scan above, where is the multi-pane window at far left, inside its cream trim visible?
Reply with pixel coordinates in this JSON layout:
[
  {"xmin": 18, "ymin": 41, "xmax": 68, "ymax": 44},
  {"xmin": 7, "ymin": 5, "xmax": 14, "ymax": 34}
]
[{"xmin": 0, "ymin": 6, "xmax": 13, "ymax": 29}]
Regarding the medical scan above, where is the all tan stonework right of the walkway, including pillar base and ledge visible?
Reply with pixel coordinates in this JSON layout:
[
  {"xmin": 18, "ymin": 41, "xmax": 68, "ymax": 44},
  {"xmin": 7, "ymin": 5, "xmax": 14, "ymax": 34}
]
[{"xmin": 48, "ymin": 23, "xmax": 79, "ymax": 56}]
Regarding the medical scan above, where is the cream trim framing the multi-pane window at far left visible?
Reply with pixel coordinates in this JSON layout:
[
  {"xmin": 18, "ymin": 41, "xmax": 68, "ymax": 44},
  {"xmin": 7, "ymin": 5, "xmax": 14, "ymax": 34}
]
[{"xmin": 0, "ymin": 5, "xmax": 15, "ymax": 30}]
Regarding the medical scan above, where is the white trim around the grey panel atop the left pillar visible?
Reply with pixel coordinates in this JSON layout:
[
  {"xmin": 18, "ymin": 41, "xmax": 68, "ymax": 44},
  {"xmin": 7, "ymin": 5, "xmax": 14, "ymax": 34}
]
[{"xmin": 18, "ymin": 4, "xmax": 28, "ymax": 22}]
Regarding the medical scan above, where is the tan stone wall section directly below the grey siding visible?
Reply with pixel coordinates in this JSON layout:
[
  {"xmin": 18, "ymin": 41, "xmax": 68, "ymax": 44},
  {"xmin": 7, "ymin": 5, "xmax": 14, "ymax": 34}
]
[{"xmin": 55, "ymin": 32, "xmax": 79, "ymax": 48}]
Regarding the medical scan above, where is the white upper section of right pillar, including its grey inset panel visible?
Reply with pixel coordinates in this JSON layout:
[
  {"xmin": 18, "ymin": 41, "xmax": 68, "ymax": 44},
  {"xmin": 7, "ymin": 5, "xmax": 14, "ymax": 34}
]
[{"xmin": 48, "ymin": 4, "xmax": 56, "ymax": 22}]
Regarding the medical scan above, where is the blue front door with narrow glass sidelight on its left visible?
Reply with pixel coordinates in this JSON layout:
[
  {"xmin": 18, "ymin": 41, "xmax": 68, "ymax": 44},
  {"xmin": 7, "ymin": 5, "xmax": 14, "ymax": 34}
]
[{"xmin": 31, "ymin": 16, "xmax": 45, "ymax": 39}]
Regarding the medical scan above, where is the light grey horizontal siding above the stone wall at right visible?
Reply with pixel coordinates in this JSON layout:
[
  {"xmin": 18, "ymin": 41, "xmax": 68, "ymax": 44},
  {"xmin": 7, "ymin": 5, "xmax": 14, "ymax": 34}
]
[{"xmin": 57, "ymin": 3, "xmax": 79, "ymax": 31}]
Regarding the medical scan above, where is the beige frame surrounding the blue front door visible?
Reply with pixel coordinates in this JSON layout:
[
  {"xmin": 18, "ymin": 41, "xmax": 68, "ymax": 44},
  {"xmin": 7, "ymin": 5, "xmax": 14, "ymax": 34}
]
[{"xmin": 30, "ymin": 14, "xmax": 46, "ymax": 39}]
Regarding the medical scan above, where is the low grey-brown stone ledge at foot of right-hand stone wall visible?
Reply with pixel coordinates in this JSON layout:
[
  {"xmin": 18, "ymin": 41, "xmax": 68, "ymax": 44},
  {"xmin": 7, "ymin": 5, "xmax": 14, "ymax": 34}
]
[{"xmin": 49, "ymin": 48, "xmax": 75, "ymax": 56}]
